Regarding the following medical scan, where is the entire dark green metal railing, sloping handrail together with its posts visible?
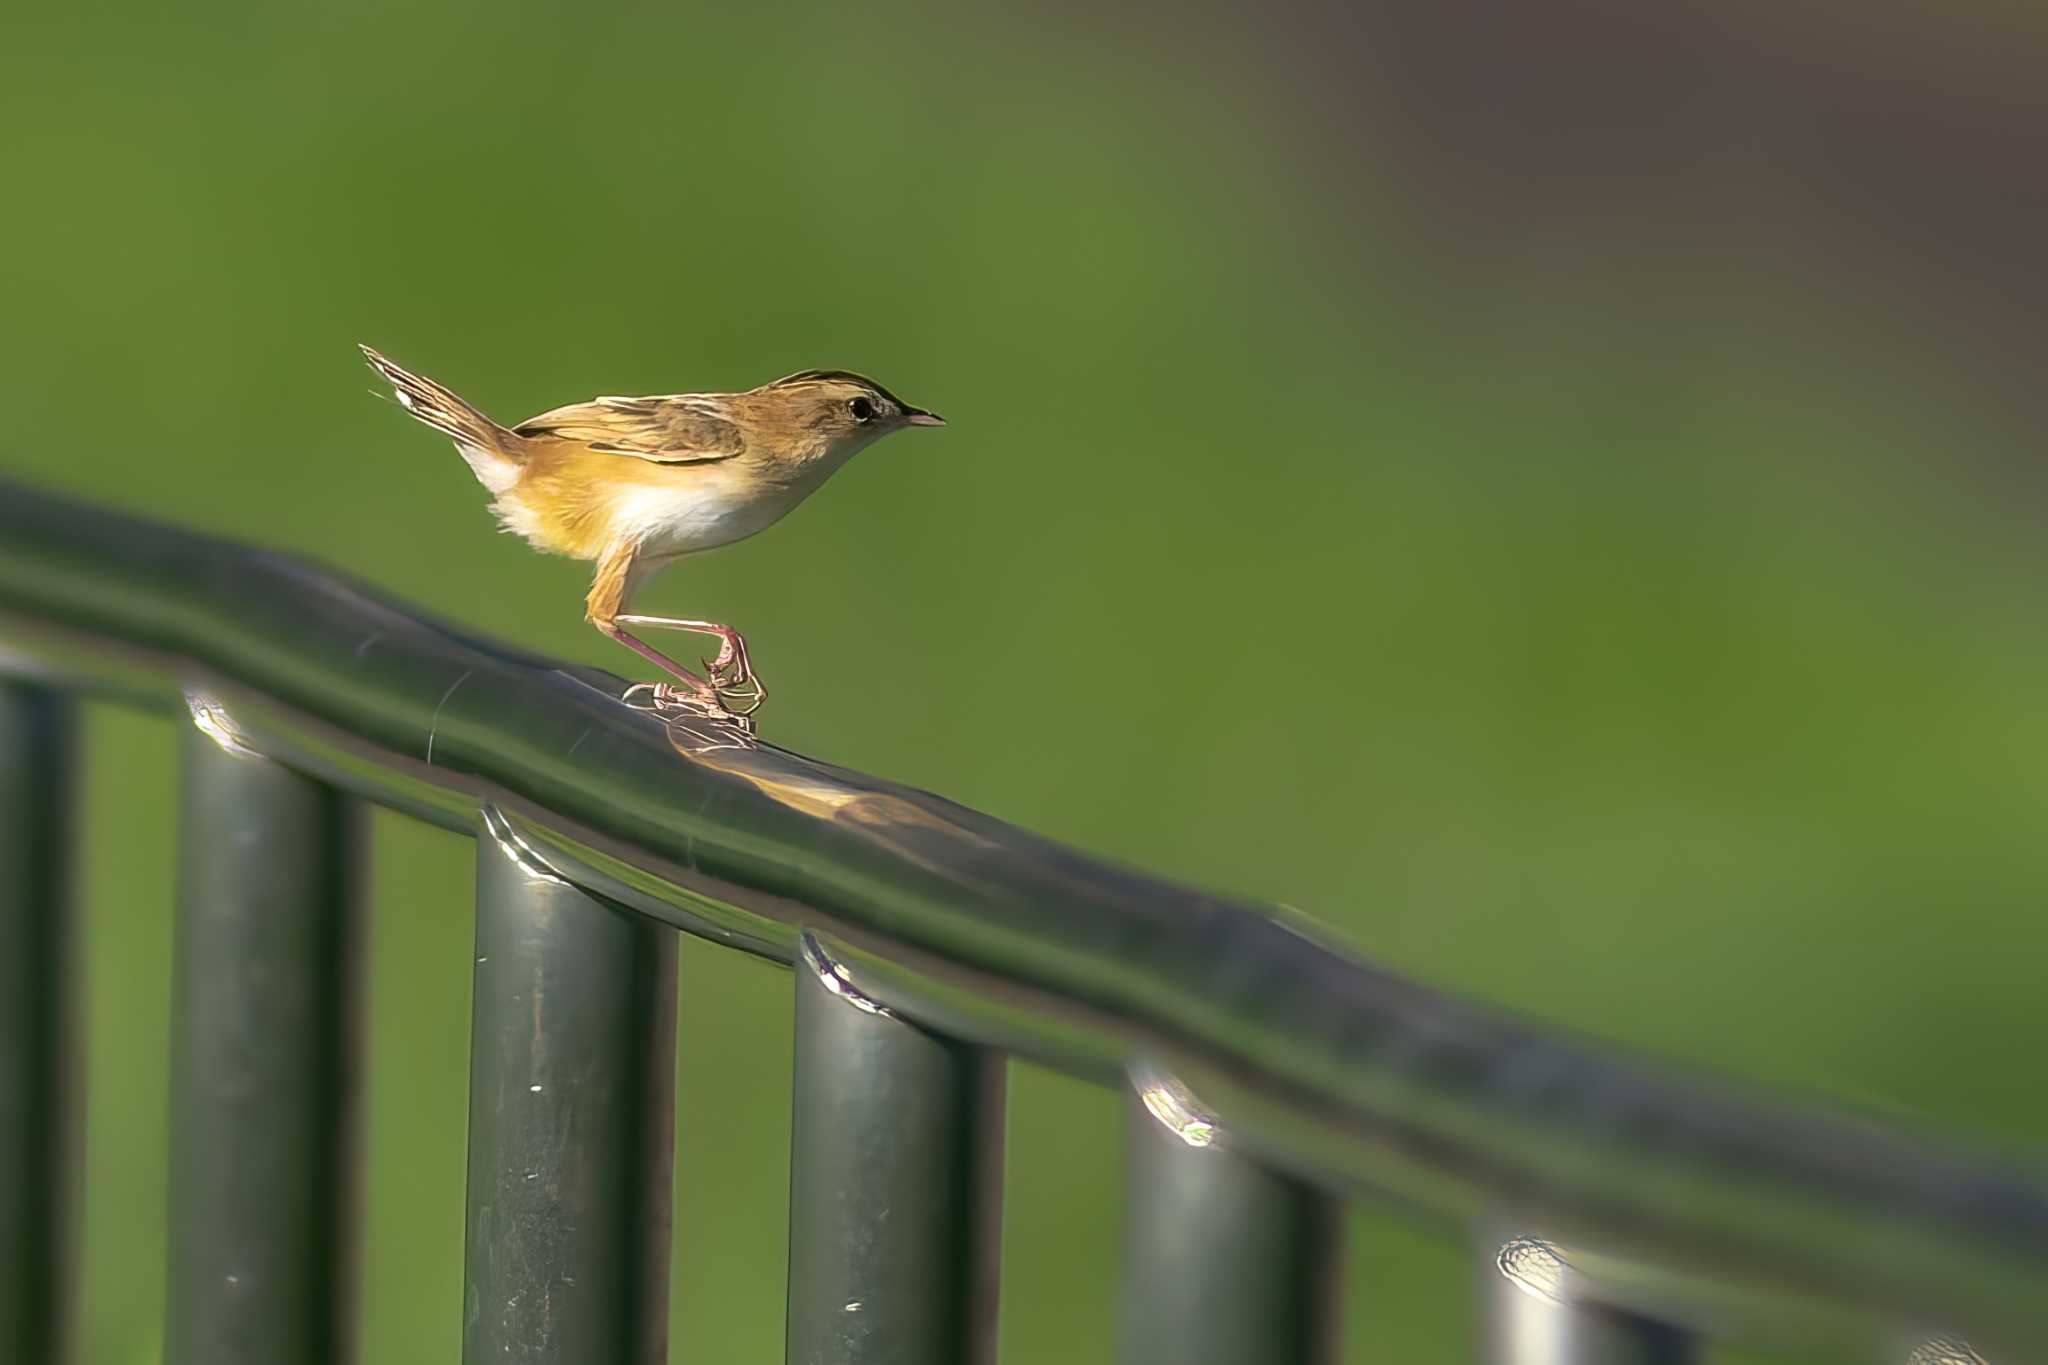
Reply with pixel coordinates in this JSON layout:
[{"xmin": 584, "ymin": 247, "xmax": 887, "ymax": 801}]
[{"xmin": 0, "ymin": 472, "xmax": 2048, "ymax": 1365}]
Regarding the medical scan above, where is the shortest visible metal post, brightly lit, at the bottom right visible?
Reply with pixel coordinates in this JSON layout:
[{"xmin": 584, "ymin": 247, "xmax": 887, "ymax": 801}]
[{"xmin": 1481, "ymin": 1236, "xmax": 1698, "ymax": 1365}]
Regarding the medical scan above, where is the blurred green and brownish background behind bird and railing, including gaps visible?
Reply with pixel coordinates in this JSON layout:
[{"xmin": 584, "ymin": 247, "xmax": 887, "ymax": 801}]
[{"xmin": 0, "ymin": 0, "xmax": 2048, "ymax": 1365}]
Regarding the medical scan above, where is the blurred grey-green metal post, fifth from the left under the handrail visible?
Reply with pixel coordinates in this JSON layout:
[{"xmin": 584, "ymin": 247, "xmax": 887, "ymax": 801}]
[{"xmin": 1120, "ymin": 1070, "xmax": 1339, "ymax": 1365}]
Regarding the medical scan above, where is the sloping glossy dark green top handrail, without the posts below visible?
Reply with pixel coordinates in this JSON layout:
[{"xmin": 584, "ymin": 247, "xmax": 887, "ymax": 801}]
[{"xmin": 0, "ymin": 481, "xmax": 2048, "ymax": 1359}]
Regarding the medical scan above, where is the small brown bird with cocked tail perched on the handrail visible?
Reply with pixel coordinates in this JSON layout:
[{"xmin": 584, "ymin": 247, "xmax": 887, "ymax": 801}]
[{"xmin": 362, "ymin": 346, "xmax": 946, "ymax": 718}]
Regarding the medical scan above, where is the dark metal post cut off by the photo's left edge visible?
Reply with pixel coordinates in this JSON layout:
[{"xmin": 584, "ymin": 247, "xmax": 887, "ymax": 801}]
[{"xmin": 0, "ymin": 681, "xmax": 78, "ymax": 1365}]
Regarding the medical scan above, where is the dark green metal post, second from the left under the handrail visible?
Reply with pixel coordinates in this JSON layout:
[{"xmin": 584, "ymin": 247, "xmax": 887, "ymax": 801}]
[{"xmin": 164, "ymin": 716, "xmax": 365, "ymax": 1365}]
